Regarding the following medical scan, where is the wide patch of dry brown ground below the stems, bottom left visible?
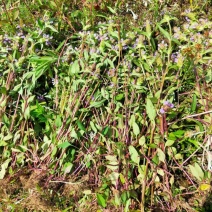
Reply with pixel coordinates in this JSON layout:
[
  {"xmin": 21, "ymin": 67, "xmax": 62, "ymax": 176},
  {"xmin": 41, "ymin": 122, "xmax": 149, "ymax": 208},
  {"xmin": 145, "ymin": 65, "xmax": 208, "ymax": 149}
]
[{"xmin": 0, "ymin": 169, "xmax": 99, "ymax": 212}]
